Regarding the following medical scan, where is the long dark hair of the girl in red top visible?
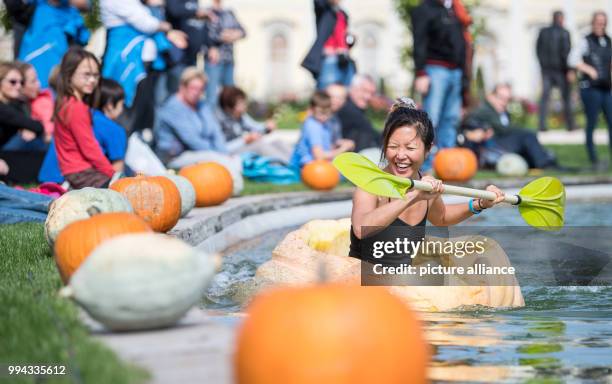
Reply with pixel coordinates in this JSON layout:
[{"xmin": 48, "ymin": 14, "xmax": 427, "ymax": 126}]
[{"xmin": 53, "ymin": 47, "xmax": 100, "ymax": 119}]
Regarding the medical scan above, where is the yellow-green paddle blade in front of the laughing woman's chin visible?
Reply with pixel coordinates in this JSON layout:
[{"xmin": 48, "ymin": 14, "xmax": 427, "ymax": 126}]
[{"xmin": 332, "ymin": 152, "xmax": 412, "ymax": 199}]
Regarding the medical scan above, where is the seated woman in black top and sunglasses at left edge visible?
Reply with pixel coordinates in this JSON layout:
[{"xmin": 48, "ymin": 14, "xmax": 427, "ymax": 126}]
[{"xmin": 0, "ymin": 63, "xmax": 45, "ymax": 182}]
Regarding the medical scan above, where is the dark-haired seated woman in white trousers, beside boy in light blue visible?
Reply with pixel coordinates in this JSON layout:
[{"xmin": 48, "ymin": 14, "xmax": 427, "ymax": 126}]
[{"xmin": 216, "ymin": 86, "xmax": 293, "ymax": 163}]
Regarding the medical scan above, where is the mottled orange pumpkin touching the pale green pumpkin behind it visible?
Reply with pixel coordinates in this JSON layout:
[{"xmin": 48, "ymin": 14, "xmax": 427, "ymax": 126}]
[{"xmin": 110, "ymin": 176, "xmax": 181, "ymax": 232}]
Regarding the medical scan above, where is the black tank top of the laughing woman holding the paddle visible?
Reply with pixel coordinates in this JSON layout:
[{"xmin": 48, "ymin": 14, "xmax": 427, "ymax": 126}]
[{"xmin": 349, "ymin": 198, "xmax": 429, "ymax": 264}]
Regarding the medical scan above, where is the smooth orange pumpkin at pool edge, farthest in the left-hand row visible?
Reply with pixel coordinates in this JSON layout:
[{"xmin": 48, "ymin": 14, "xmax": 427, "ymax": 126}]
[{"xmin": 179, "ymin": 162, "xmax": 234, "ymax": 207}]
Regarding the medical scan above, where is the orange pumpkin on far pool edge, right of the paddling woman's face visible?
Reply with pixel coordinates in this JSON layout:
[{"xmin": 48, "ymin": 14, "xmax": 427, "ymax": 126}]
[{"xmin": 433, "ymin": 148, "xmax": 478, "ymax": 182}]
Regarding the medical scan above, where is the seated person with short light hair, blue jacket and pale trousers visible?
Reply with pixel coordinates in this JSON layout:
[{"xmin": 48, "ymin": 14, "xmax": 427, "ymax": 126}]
[{"xmin": 153, "ymin": 67, "xmax": 243, "ymax": 194}]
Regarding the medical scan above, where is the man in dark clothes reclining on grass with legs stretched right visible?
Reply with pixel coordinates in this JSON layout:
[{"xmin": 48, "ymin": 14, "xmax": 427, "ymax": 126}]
[{"xmin": 467, "ymin": 84, "xmax": 560, "ymax": 169}]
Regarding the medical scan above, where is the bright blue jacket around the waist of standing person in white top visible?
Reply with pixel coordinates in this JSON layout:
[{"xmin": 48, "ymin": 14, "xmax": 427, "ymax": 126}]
[{"xmin": 102, "ymin": 24, "xmax": 172, "ymax": 108}]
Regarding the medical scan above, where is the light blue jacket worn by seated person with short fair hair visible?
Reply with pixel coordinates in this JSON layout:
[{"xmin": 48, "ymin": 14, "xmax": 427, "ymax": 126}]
[{"xmin": 154, "ymin": 95, "xmax": 227, "ymax": 162}]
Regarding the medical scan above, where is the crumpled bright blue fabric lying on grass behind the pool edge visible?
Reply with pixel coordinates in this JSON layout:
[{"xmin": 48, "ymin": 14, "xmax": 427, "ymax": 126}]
[{"xmin": 241, "ymin": 152, "xmax": 301, "ymax": 184}]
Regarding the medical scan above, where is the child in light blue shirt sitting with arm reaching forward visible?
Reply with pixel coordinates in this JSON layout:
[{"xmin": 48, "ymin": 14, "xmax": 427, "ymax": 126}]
[{"xmin": 291, "ymin": 91, "xmax": 355, "ymax": 169}]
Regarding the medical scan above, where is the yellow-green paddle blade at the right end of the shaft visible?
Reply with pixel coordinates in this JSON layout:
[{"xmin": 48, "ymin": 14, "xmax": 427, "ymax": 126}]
[{"xmin": 519, "ymin": 176, "xmax": 565, "ymax": 231}]
